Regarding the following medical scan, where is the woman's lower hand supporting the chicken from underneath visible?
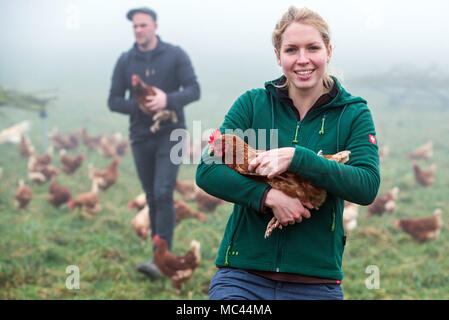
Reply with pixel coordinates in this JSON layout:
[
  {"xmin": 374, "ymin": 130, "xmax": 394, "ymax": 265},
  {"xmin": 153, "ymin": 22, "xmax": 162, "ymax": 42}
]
[{"xmin": 265, "ymin": 189, "xmax": 313, "ymax": 227}]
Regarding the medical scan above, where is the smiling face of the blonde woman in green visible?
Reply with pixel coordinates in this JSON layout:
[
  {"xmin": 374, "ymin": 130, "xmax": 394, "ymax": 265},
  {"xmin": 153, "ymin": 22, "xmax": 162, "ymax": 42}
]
[{"xmin": 275, "ymin": 22, "xmax": 332, "ymax": 90}]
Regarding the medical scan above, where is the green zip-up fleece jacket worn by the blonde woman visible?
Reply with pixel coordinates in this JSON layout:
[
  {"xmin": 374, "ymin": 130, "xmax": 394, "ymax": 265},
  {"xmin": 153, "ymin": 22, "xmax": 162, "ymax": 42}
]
[{"xmin": 196, "ymin": 78, "xmax": 380, "ymax": 279}]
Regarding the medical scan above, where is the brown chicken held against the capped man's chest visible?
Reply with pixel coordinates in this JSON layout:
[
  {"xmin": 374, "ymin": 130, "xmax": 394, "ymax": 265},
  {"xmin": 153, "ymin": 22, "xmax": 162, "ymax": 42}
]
[{"xmin": 131, "ymin": 74, "xmax": 178, "ymax": 133}]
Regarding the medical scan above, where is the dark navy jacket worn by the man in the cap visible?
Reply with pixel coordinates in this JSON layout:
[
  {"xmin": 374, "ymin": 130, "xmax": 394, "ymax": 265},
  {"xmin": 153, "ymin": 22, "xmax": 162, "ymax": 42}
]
[{"xmin": 108, "ymin": 36, "xmax": 200, "ymax": 142}]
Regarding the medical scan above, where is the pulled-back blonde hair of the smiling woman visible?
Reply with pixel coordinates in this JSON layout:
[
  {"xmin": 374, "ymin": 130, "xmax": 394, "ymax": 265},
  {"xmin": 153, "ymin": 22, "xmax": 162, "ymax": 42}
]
[{"xmin": 272, "ymin": 6, "xmax": 334, "ymax": 89}]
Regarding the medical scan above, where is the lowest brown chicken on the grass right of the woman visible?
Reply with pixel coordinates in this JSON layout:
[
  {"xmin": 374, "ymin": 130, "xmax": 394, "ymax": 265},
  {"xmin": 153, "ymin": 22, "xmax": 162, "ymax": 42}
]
[{"xmin": 395, "ymin": 209, "xmax": 443, "ymax": 242}]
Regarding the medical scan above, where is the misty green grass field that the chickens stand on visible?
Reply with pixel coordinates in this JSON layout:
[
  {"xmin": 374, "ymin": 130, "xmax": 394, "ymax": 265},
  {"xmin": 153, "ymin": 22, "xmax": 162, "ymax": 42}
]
[{"xmin": 0, "ymin": 85, "xmax": 449, "ymax": 299}]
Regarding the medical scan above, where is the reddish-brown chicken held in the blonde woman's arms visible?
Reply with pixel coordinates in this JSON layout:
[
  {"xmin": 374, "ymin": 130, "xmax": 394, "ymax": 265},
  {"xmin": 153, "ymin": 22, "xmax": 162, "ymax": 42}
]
[{"xmin": 209, "ymin": 129, "xmax": 351, "ymax": 238}]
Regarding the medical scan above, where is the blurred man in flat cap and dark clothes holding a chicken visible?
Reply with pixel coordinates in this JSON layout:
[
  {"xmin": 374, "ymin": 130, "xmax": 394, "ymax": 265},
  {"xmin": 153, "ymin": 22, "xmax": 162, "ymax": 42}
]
[{"xmin": 108, "ymin": 8, "xmax": 200, "ymax": 277}]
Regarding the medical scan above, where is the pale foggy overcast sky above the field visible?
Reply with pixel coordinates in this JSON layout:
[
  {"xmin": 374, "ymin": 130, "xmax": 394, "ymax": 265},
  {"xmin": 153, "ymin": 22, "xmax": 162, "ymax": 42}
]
[{"xmin": 0, "ymin": 0, "xmax": 449, "ymax": 89}]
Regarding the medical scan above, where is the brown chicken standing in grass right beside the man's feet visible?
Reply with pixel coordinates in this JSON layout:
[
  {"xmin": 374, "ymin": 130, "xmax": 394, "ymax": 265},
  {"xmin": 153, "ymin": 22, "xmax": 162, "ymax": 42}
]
[{"xmin": 153, "ymin": 235, "xmax": 201, "ymax": 293}]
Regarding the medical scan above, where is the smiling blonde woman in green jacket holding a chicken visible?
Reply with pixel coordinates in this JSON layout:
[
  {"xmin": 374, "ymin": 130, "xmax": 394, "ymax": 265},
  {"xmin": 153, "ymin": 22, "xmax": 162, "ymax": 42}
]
[{"xmin": 196, "ymin": 7, "xmax": 380, "ymax": 299}]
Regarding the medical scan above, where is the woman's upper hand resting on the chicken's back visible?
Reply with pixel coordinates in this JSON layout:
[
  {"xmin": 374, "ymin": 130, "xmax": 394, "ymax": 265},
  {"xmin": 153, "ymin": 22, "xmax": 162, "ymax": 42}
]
[{"xmin": 248, "ymin": 147, "xmax": 295, "ymax": 179}]
